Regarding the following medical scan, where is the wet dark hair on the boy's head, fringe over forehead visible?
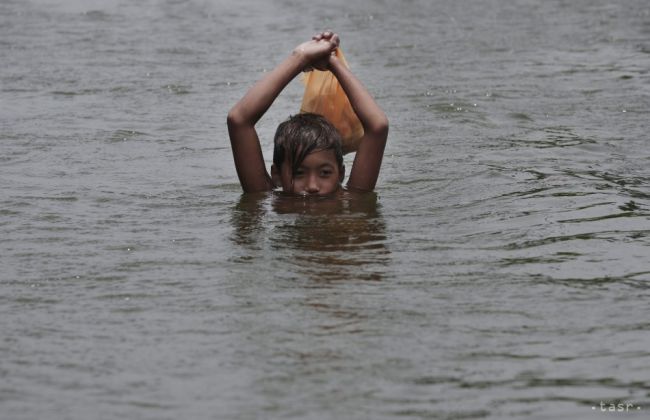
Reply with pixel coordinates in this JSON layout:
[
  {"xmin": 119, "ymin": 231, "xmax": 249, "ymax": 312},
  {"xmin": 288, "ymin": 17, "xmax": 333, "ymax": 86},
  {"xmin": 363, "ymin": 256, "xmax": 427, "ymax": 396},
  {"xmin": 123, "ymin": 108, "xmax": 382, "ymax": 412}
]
[{"xmin": 273, "ymin": 112, "xmax": 343, "ymax": 174}]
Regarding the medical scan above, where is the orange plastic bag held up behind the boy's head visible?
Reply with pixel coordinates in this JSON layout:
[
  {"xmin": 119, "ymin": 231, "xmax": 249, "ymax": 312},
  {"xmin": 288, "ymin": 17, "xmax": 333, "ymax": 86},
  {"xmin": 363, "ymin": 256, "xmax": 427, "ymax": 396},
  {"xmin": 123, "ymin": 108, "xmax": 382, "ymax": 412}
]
[{"xmin": 300, "ymin": 48, "xmax": 363, "ymax": 154}]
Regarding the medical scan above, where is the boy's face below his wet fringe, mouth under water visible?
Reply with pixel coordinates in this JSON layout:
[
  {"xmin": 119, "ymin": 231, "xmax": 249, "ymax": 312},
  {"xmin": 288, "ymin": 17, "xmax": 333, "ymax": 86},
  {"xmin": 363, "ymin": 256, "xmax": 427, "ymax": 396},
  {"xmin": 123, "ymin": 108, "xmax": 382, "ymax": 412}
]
[{"xmin": 281, "ymin": 149, "xmax": 344, "ymax": 195}]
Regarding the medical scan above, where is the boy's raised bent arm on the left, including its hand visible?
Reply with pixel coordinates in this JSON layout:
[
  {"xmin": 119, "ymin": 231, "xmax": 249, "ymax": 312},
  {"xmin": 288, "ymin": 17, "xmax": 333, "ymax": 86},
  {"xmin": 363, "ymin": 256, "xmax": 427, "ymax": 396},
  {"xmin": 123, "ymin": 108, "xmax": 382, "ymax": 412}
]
[{"xmin": 228, "ymin": 37, "xmax": 337, "ymax": 192}]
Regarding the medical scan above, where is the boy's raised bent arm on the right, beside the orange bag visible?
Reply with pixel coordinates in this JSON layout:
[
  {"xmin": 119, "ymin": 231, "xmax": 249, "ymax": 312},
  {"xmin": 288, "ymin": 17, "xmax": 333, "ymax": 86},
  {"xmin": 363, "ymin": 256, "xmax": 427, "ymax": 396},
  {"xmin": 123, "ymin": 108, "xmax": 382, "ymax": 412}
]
[{"xmin": 329, "ymin": 46, "xmax": 388, "ymax": 191}]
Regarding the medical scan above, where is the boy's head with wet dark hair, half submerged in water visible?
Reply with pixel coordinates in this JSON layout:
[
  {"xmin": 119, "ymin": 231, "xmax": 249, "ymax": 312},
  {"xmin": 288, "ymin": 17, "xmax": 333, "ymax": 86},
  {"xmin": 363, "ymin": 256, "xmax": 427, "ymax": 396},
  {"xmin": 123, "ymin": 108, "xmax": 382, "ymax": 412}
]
[{"xmin": 271, "ymin": 113, "xmax": 345, "ymax": 195}]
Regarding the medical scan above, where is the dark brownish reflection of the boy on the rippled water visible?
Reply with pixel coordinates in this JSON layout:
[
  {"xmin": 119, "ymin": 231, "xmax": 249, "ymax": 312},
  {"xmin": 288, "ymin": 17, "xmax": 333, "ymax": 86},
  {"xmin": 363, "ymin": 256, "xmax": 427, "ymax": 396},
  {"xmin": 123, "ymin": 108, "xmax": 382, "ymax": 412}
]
[{"xmin": 231, "ymin": 191, "xmax": 389, "ymax": 281}]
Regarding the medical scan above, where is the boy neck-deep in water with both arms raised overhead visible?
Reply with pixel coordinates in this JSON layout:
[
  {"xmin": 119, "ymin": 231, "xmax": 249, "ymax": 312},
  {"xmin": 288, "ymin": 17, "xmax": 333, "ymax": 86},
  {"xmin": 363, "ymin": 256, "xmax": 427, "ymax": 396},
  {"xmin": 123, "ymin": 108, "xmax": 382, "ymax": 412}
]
[{"xmin": 228, "ymin": 31, "xmax": 388, "ymax": 195}]
